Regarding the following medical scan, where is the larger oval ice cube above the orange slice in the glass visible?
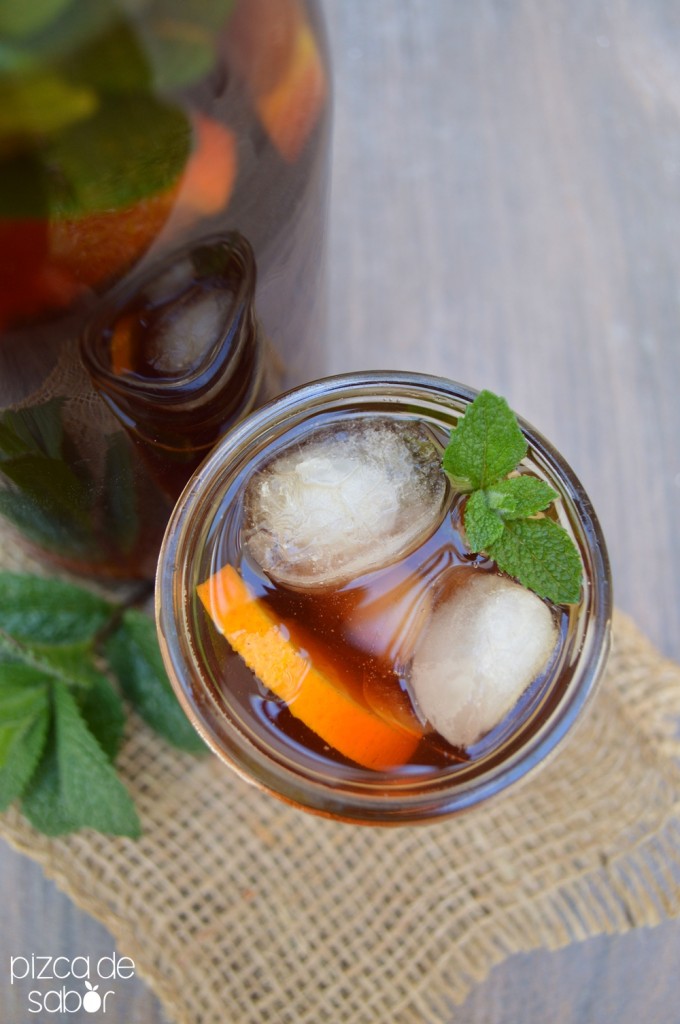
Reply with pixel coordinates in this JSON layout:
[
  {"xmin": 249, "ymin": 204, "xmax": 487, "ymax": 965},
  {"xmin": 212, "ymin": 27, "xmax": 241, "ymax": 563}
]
[{"xmin": 244, "ymin": 416, "xmax": 448, "ymax": 587}]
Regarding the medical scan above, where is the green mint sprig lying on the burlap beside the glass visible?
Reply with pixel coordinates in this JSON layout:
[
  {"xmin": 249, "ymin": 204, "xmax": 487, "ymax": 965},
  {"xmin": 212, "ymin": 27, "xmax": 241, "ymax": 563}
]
[{"xmin": 0, "ymin": 572, "xmax": 205, "ymax": 838}]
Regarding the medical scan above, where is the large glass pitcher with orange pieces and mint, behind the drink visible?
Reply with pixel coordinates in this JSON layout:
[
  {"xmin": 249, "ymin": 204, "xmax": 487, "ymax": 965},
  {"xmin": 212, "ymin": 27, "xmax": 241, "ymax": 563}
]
[{"xmin": 0, "ymin": 0, "xmax": 330, "ymax": 577}]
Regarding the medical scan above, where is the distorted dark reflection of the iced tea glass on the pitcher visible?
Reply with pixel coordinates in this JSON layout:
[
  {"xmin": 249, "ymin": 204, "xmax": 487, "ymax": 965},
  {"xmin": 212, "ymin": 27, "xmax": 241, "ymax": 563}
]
[{"xmin": 81, "ymin": 232, "xmax": 280, "ymax": 502}]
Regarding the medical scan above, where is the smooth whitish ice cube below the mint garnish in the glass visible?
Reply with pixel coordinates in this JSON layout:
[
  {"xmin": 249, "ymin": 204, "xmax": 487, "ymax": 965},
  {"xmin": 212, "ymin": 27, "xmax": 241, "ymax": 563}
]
[{"xmin": 411, "ymin": 568, "xmax": 557, "ymax": 746}]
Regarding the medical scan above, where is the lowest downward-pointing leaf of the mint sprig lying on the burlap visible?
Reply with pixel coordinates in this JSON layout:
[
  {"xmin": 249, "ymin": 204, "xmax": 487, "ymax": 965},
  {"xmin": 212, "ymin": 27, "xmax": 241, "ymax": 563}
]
[{"xmin": 23, "ymin": 682, "xmax": 140, "ymax": 838}]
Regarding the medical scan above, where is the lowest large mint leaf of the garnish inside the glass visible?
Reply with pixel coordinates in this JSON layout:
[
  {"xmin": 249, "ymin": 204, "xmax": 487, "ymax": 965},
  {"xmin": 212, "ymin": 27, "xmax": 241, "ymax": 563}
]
[{"xmin": 486, "ymin": 517, "xmax": 583, "ymax": 604}]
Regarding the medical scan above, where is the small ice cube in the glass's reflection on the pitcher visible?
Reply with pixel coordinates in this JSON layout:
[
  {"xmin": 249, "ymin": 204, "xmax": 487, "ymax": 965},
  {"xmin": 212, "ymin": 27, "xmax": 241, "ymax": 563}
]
[{"xmin": 145, "ymin": 288, "xmax": 228, "ymax": 376}]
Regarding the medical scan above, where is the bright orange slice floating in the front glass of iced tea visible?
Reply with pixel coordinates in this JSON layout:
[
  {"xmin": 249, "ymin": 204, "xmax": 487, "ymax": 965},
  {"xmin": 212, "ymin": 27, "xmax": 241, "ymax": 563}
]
[{"xmin": 197, "ymin": 565, "xmax": 420, "ymax": 769}]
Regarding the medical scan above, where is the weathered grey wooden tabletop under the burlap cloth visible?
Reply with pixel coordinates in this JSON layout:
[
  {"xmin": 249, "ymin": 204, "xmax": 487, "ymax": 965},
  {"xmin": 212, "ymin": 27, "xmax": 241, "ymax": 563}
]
[{"xmin": 0, "ymin": 0, "xmax": 680, "ymax": 1024}]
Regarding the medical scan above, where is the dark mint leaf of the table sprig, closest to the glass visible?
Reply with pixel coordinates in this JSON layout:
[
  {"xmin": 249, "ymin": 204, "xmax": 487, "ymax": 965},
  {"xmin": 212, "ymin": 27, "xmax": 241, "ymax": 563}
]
[{"xmin": 104, "ymin": 609, "xmax": 206, "ymax": 753}]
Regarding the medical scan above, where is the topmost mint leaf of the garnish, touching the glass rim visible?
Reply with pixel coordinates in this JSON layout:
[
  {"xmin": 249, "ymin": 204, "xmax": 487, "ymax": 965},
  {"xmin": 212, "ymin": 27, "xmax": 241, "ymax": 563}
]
[{"xmin": 442, "ymin": 391, "xmax": 527, "ymax": 493}]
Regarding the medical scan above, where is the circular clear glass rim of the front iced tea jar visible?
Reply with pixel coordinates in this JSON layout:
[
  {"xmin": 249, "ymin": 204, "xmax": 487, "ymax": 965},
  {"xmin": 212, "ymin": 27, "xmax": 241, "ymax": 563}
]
[{"xmin": 156, "ymin": 371, "xmax": 612, "ymax": 824}]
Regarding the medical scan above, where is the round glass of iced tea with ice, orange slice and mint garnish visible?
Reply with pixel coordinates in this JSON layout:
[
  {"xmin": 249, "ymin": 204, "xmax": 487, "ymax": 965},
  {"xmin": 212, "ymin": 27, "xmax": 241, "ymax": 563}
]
[{"xmin": 157, "ymin": 373, "xmax": 611, "ymax": 824}]
